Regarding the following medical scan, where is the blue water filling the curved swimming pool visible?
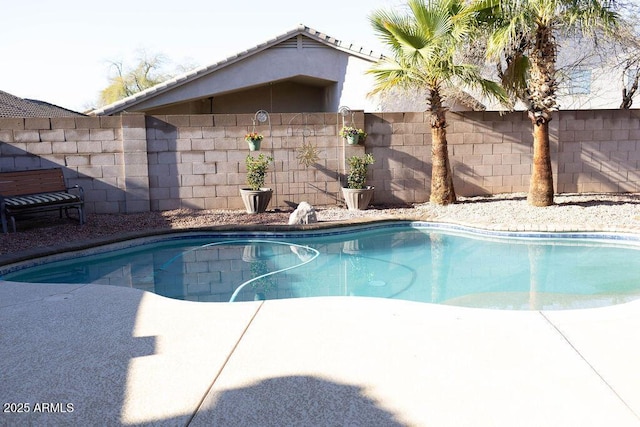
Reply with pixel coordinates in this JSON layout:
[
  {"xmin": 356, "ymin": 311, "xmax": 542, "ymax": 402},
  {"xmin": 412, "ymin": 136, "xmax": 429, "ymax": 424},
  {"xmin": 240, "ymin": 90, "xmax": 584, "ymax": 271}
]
[{"xmin": 2, "ymin": 222, "xmax": 640, "ymax": 310}]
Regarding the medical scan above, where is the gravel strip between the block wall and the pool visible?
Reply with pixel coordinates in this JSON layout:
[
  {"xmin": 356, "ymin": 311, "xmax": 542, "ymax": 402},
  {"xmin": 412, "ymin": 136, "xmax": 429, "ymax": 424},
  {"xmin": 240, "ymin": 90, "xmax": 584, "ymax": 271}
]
[{"xmin": 0, "ymin": 193, "xmax": 640, "ymax": 254}]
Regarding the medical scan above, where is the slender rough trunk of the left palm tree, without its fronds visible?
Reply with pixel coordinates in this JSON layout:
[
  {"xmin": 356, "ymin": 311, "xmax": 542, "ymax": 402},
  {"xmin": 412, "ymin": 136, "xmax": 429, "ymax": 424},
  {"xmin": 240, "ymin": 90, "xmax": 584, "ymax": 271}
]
[{"xmin": 429, "ymin": 108, "xmax": 456, "ymax": 205}]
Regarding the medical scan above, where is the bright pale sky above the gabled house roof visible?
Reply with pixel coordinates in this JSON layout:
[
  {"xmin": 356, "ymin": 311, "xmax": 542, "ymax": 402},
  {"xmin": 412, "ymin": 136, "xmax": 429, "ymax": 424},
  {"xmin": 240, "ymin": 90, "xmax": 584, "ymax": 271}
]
[{"xmin": 0, "ymin": 0, "xmax": 406, "ymax": 111}]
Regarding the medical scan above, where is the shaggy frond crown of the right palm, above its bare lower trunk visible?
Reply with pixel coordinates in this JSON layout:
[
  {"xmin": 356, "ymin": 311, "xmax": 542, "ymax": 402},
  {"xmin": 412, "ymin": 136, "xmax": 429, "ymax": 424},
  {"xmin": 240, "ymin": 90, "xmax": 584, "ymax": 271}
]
[{"xmin": 482, "ymin": 0, "xmax": 619, "ymax": 110}]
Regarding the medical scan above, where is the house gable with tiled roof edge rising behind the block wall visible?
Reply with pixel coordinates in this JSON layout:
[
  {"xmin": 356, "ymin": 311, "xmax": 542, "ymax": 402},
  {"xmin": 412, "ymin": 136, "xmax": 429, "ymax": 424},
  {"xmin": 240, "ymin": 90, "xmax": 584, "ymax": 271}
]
[{"xmin": 92, "ymin": 26, "xmax": 380, "ymax": 115}]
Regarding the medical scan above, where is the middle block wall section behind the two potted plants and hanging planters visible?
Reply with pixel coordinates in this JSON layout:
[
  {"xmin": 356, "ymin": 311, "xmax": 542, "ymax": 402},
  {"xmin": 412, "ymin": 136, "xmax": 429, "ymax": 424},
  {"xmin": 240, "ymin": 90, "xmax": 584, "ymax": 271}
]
[{"xmin": 146, "ymin": 112, "xmax": 365, "ymax": 210}]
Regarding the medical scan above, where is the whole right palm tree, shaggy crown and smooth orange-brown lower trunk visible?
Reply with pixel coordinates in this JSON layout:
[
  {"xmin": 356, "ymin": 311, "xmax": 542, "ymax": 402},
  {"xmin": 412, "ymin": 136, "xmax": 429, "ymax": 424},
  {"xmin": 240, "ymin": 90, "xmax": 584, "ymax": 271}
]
[{"xmin": 482, "ymin": 0, "xmax": 618, "ymax": 206}]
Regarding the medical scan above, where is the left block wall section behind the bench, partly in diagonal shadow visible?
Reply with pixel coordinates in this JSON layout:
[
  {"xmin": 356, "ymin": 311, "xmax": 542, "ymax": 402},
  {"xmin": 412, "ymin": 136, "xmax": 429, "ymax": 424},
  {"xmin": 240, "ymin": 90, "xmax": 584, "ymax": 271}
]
[{"xmin": 0, "ymin": 116, "xmax": 126, "ymax": 213}]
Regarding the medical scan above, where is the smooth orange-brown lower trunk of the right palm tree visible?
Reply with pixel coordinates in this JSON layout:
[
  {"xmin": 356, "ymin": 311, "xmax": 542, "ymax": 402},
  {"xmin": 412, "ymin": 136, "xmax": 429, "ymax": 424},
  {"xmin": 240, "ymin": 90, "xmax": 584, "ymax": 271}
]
[{"xmin": 527, "ymin": 118, "xmax": 554, "ymax": 206}]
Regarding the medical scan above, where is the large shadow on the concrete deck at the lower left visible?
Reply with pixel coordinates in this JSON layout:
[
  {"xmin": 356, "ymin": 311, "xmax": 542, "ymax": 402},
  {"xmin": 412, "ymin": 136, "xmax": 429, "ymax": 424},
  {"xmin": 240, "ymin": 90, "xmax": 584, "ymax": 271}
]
[{"xmin": 0, "ymin": 282, "xmax": 157, "ymax": 426}]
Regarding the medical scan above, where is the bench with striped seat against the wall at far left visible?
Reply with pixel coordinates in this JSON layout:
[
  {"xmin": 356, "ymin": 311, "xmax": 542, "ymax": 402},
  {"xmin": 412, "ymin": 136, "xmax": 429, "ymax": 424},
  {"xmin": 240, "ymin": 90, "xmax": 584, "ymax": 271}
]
[{"xmin": 0, "ymin": 168, "xmax": 85, "ymax": 233}]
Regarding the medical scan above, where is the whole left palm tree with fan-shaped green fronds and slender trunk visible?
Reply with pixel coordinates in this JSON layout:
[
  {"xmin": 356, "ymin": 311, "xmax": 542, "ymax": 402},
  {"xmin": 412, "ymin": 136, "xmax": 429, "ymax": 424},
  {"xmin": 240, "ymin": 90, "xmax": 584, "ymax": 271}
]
[{"xmin": 369, "ymin": 0, "xmax": 507, "ymax": 205}]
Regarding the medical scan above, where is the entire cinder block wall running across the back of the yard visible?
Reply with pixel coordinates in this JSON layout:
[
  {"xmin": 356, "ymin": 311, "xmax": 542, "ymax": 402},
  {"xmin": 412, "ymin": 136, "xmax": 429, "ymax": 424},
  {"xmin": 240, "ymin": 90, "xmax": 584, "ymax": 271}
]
[{"xmin": 0, "ymin": 110, "xmax": 640, "ymax": 213}]
